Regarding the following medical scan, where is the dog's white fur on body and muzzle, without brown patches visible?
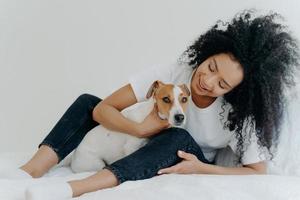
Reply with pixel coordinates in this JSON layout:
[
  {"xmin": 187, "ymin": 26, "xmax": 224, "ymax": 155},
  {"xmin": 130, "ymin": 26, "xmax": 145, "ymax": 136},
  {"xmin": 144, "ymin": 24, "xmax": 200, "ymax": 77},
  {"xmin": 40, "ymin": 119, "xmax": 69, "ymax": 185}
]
[{"xmin": 71, "ymin": 80, "xmax": 189, "ymax": 172}]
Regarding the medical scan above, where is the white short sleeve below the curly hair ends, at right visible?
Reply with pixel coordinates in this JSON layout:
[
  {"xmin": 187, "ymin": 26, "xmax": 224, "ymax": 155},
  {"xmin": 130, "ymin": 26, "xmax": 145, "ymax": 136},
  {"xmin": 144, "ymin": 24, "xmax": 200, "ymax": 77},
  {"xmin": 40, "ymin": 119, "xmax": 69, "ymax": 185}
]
[{"xmin": 228, "ymin": 120, "xmax": 267, "ymax": 165}]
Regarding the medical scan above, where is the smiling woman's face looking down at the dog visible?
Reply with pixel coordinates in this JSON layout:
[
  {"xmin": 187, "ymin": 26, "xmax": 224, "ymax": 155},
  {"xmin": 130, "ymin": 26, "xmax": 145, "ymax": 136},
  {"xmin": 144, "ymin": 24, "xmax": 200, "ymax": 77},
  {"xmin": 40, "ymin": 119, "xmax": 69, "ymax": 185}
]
[{"xmin": 191, "ymin": 53, "xmax": 244, "ymax": 97}]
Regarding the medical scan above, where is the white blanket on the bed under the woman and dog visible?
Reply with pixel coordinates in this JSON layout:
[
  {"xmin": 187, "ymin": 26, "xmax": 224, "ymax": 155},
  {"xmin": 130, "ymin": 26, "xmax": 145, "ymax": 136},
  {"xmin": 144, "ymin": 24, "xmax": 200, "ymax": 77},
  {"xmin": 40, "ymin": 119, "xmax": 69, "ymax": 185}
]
[{"xmin": 0, "ymin": 153, "xmax": 300, "ymax": 200}]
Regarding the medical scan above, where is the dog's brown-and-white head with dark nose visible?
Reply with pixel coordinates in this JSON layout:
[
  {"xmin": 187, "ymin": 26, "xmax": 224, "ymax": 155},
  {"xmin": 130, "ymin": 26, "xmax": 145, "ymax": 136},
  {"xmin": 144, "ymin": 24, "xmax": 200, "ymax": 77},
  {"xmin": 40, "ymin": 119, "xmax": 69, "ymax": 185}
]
[{"xmin": 146, "ymin": 80, "xmax": 191, "ymax": 127}]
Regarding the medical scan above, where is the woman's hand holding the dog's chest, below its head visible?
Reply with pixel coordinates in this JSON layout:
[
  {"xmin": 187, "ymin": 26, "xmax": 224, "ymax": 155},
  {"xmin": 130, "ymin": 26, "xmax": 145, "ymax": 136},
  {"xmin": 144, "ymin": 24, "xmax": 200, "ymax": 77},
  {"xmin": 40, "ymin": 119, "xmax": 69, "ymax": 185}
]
[{"xmin": 139, "ymin": 104, "xmax": 171, "ymax": 138}]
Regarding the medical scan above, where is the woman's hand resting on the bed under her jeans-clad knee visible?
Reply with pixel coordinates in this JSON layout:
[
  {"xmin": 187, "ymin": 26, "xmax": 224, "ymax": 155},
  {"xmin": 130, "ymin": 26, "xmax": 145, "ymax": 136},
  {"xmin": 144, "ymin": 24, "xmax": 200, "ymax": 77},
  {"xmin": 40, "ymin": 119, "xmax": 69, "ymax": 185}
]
[{"xmin": 157, "ymin": 151, "xmax": 204, "ymax": 174}]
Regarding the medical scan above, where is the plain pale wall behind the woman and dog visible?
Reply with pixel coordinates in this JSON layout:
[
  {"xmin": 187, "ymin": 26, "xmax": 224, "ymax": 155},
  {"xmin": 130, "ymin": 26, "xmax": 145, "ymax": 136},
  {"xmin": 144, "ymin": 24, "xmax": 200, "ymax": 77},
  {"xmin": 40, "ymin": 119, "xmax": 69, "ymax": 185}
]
[{"xmin": 0, "ymin": 0, "xmax": 300, "ymax": 155}]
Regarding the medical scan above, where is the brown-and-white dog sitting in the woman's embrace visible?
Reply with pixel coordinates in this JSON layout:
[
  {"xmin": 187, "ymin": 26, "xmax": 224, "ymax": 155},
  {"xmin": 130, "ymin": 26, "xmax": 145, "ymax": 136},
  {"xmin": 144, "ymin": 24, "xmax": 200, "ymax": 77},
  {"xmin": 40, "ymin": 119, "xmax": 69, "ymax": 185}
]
[{"xmin": 70, "ymin": 80, "xmax": 190, "ymax": 173}]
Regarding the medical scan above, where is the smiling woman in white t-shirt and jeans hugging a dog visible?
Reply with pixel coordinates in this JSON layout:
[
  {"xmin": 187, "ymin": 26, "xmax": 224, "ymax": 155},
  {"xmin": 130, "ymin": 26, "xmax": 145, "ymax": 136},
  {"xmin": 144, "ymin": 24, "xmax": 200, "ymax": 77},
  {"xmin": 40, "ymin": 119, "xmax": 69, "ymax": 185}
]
[{"xmin": 2, "ymin": 11, "xmax": 299, "ymax": 199}]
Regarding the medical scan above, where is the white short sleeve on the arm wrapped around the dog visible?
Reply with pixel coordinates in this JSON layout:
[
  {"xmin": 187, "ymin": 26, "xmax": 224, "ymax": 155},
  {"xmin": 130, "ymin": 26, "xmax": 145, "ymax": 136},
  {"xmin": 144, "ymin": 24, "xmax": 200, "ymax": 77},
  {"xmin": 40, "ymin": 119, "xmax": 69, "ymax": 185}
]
[{"xmin": 129, "ymin": 64, "xmax": 176, "ymax": 102}]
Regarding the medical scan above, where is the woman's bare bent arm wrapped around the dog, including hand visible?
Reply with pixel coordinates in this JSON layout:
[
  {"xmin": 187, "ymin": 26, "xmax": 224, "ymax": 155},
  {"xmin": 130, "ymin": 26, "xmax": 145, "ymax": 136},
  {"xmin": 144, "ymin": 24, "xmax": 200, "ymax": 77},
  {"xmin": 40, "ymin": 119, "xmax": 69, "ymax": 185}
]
[{"xmin": 93, "ymin": 84, "xmax": 169, "ymax": 137}]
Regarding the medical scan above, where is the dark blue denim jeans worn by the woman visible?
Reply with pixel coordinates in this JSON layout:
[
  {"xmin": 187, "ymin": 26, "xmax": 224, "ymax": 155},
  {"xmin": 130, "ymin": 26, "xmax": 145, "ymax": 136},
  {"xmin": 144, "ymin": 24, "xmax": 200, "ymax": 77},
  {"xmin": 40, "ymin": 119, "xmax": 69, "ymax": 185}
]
[{"xmin": 39, "ymin": 94, "xmax": 213, "ymax": 183}]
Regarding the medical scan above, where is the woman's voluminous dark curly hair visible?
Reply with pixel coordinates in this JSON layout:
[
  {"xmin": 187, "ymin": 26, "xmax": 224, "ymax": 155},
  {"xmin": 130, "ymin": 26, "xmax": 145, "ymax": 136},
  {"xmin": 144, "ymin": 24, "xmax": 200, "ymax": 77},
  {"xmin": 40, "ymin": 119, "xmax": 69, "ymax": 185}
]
[{"xmin": 181, "ymin": 10, "xmax": 299, "ymax": 163}]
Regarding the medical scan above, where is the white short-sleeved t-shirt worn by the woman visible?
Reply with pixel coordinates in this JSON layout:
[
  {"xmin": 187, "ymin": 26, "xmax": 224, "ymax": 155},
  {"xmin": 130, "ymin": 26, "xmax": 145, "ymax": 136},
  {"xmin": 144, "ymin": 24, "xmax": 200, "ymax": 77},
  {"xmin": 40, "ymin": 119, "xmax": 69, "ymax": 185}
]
[{"xmin": 129, "ymin": 62, "xmax": 266, "ymax": 165}]
